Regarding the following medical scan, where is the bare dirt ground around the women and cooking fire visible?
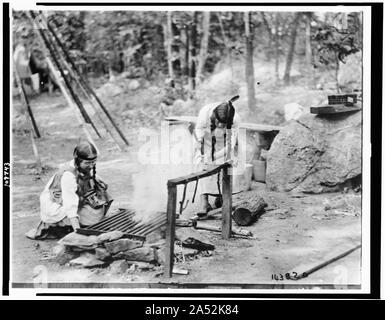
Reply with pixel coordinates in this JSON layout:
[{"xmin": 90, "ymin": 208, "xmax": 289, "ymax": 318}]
[{"xmin": 11, "ymin": 94, "xmax": 361, "ymax": 289}]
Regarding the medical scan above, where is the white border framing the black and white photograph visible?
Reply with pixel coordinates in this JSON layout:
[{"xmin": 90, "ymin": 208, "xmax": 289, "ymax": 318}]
[{"xmin": 5, "ymin": 0, "xmax": 372, "ymax": 300}]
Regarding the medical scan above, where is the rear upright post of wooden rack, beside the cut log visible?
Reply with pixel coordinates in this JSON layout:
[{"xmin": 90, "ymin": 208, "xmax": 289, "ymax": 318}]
[{"xmin": 222, "ymin": 166, "xmax": 233, "ymax": 239}]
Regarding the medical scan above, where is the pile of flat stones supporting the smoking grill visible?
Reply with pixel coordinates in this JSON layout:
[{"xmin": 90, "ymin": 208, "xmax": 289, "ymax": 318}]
[{"xmin": 53, "ymin": 228, "xmax": 215, "ymax": 273}]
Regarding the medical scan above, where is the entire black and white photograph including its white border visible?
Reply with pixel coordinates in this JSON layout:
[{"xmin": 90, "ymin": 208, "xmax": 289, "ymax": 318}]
[{"xmin": 3, "ymin": 2, "xmax": 376, "ymax": 294}]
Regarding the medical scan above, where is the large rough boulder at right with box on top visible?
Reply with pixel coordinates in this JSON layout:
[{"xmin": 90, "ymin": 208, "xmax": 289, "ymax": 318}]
[{"xmin": 266, "ymin": 112, "xmax": 362, "ymax": 193}]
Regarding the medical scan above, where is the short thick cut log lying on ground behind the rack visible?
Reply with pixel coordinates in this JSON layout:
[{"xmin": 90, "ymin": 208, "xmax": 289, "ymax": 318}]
[{"xmin": 233, "ymin": 195, "xmax": 267, "ymax": 226}]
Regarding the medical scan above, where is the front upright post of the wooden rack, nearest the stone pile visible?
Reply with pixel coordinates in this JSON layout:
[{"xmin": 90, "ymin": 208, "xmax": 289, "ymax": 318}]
[{"xmin": 164, "ymin": 185, "xmax": 177, "ymax": 278}]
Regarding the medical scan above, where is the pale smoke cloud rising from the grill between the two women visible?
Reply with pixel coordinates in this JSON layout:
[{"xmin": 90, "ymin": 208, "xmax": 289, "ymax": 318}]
[{"xmin": 130, "ymin": 126, "xmax": 194, "ymax": 222}]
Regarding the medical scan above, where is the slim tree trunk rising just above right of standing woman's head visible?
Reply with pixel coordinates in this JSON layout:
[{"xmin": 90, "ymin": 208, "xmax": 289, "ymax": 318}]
[{"xmin": 245, "ymin": 12, "xmax": 256, "ymax": 112}]
